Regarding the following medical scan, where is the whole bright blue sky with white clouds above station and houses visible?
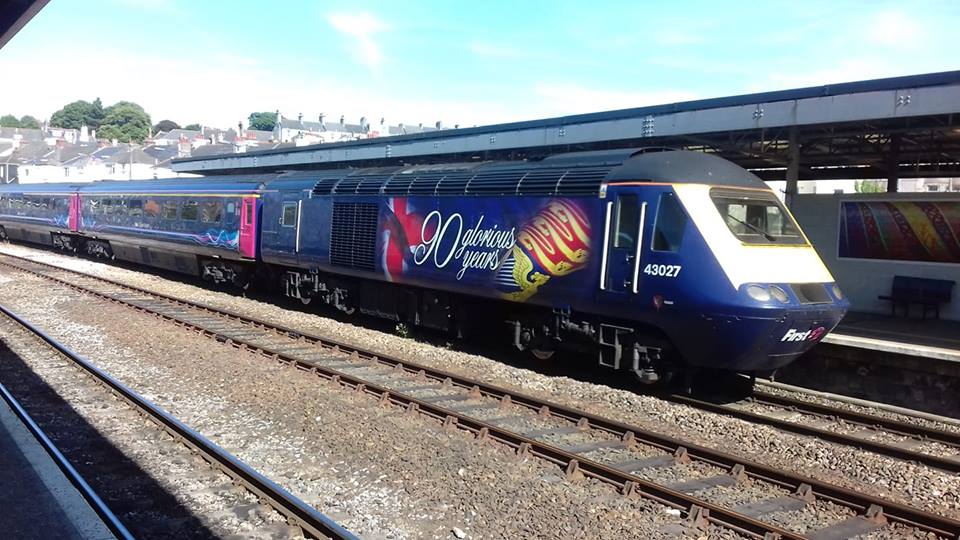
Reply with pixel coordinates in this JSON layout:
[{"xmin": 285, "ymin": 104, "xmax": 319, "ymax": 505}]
[{"xmin": 0, "ymin": 0, "xmax": 960, "ymax": 128}]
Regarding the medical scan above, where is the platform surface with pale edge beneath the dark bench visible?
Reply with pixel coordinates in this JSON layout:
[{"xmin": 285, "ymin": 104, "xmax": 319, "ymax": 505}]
[{"xmin": 823, "ymin": 312, "xmax": 960, "ymax": 362}]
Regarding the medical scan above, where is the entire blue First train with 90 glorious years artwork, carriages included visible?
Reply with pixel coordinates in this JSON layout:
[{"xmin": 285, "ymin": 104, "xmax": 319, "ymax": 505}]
[{"xmin": 0, "ymin": 150, "xmax": 849, "ymax": 382}]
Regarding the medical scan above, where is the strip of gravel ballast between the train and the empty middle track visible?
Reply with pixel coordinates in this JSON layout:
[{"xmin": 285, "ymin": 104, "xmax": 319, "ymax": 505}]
[{"xmin": 0, "ymin": 245, "xmax": 960, "ymax": 518}]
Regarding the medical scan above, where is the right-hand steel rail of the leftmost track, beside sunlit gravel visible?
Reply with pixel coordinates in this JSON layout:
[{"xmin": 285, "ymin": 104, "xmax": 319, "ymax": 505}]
[{"xmin": 0, "ymin": 305, "xmax": 356, "ymax": 540}]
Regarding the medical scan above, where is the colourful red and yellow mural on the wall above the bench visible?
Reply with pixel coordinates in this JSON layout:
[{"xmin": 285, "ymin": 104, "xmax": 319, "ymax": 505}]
[{"xmin": 838, "ymin": 200, "xmax": 960, "ymax": 264}]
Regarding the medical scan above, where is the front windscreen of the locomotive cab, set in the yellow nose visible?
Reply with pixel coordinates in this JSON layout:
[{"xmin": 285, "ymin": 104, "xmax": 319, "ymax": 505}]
[{"xmin": 710, "ymin": 189, "xmax": 807, "ymax": 244}]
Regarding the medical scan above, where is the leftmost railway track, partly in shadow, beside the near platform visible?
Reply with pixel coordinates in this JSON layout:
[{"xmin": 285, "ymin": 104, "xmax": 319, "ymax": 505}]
[{"xmin": 0, "ymin": 305, "xmax": 355, "ymax": 539}]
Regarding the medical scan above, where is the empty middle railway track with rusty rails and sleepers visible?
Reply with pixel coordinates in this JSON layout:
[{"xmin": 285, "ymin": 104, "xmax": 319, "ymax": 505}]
[{"xmin": 0, "ymin": 251, "xmax": 960, "ymax": 539}]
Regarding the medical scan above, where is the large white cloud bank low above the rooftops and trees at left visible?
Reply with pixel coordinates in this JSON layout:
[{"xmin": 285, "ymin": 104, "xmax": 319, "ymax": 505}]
[{"xmin": 2, "ymin": 43, "xmax": 528, "ymax": 128}]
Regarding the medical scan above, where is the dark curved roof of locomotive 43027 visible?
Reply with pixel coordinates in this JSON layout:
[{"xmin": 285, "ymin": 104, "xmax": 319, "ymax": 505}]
[{"xmin": 267, "ymin": 148, "xmax": 766, "ymax": 196}]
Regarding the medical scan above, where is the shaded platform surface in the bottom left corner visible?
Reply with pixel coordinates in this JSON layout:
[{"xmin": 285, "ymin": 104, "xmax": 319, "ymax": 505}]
[{"xmin": 0, "ymin": 388, "xmax": 117, "ymax": 540}]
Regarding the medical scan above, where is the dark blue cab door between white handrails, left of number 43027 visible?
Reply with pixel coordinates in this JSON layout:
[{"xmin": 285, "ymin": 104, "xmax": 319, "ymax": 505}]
[{"xmin": 600, "ymin": 189, "xmax": 647, "ymax": 294}]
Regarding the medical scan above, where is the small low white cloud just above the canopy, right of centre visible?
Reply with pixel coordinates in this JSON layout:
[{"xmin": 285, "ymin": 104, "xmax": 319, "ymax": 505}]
[{"xmin": 534, "ymin": 82, "xmax": 699, "ymax": 116}]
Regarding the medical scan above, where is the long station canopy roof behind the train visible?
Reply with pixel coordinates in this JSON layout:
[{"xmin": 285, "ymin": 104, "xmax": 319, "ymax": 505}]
[{"xmin": 173, "ymin": 71, "xmax": 960, "ymax": 180}]
